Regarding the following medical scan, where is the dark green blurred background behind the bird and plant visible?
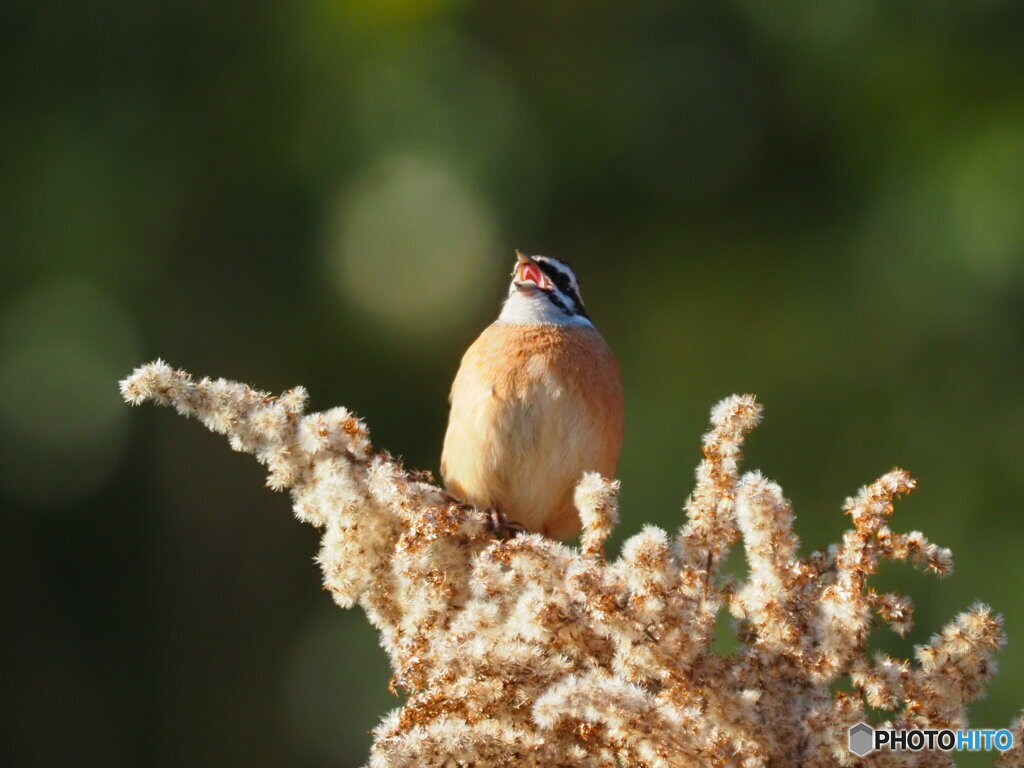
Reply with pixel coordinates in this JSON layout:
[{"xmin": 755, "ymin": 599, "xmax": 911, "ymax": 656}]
[{"xmin": 0, "ymin": 0, "xmax": 1024, "ymax": 768}]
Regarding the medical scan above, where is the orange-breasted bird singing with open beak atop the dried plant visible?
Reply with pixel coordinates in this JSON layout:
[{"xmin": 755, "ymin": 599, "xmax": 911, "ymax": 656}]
[{"xmin": 441, "ymin": 250, "xmax": 624, "ymax": 539}]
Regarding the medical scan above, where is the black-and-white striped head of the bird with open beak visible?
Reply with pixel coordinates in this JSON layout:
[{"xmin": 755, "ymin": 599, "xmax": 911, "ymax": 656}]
[{"xmin": 498, "ymin": 251, "xmax": 593, "ymax": 326}]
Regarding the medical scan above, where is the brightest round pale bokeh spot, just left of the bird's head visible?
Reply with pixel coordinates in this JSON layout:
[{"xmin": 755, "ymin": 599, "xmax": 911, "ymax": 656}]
[{"xmin": 327, "ymin": 157, "xmax": 500, "ymax": 340}]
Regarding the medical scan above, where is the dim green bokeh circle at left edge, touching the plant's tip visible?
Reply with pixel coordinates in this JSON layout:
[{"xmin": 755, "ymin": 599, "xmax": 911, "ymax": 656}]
[{"xmin": 0, "ymin": 284, "xmax": 138, "ymax": 506}]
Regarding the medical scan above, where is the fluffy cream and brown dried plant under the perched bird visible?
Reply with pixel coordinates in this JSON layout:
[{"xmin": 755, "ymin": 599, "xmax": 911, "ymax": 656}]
[{"xmin": 121, "ymin": 360, "xmax": 1024, "ymax": 768}]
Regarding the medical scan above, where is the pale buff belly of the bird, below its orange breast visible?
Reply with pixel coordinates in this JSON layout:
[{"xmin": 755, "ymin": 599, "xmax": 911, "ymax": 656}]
[{"xmin": 442, "ymin": 377, "xmax": 621, "ymax": 537}]
